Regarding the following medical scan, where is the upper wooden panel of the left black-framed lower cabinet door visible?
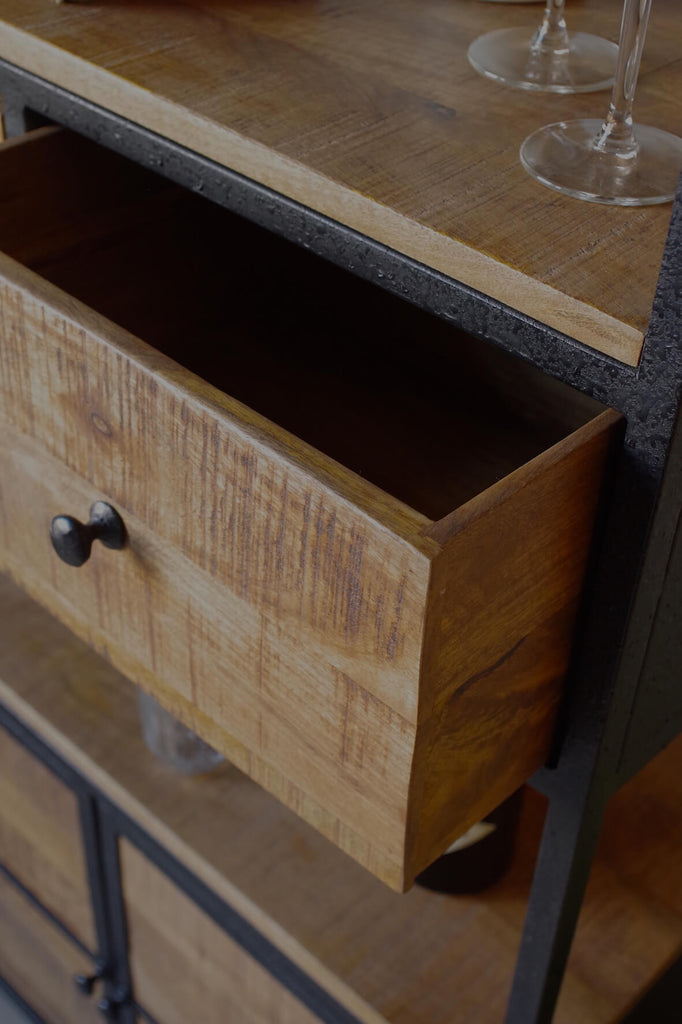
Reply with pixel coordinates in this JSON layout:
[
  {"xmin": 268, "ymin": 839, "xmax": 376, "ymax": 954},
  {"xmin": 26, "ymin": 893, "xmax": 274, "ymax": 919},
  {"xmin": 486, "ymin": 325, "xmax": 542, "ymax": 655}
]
[{"xmin": 0, "ymin": 729, "xmax": 97, "ymax": 953}]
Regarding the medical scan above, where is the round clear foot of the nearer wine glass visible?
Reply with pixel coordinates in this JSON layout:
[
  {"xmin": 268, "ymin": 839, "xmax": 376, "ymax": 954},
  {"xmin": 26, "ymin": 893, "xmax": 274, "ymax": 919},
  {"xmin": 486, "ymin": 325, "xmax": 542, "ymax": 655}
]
[{"xmin": 520, "ymin": 118, "xmax": 682, "ymax": 206}]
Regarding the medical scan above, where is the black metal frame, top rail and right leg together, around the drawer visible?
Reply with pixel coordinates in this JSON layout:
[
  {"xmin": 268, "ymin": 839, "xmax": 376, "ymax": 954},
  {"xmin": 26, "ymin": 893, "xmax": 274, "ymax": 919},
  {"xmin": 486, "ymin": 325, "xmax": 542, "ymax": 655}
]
[{"xmin": 0, "ymin": 61, "xmax": 682, "ymax": 1024}]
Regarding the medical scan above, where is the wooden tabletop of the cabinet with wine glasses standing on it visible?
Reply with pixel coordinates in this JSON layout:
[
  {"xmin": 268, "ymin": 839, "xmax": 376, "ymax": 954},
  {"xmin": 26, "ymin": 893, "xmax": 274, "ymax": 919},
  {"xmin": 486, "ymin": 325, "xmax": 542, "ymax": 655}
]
[{"xmin": 0, "ymin": 0, "xmax": 682, "ymax": 365}]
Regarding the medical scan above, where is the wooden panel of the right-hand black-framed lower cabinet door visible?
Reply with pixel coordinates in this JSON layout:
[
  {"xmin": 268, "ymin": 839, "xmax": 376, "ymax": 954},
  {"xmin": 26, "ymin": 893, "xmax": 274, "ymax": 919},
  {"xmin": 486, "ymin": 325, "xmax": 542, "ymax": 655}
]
[{"xmin": 121, "ymin": 840, "xmax": 318, "ymax": 1024}]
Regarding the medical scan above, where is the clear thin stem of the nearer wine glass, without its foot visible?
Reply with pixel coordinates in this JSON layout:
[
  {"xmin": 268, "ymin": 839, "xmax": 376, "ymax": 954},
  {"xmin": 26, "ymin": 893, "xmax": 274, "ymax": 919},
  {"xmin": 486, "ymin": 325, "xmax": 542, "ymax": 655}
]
[{"xmin": 595, "ymin": 0, "xmax": 651, "ymax": 158}]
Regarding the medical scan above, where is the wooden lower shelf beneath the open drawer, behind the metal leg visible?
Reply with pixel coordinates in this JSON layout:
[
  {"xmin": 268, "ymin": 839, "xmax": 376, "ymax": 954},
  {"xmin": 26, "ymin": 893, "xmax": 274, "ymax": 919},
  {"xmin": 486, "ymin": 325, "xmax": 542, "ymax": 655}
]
[{"xmin": 0, "ymin": 579, "xmax": 682, "ymax": 1024}]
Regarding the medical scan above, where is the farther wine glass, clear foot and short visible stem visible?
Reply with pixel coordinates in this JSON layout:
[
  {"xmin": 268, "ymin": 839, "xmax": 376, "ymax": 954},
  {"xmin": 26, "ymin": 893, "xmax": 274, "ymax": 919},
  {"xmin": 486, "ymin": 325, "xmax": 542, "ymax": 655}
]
[{"xmin": 468, "ymin": 0, "xmax": 617, "ymax": 92}]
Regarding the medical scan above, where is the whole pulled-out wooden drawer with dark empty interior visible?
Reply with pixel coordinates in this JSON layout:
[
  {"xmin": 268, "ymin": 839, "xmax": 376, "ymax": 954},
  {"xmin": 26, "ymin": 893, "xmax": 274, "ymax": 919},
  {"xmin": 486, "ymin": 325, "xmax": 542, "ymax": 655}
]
[{"xmin": 0, "ymin": 129, "xmax": 620, "ymax": 889}]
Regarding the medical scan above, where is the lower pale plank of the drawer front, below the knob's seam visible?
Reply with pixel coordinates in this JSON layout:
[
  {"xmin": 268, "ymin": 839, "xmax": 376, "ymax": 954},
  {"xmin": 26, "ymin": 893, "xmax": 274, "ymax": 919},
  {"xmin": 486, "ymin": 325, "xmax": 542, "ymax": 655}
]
[{"xmin": 0, "ymin": 427, "xmax": 414, "ymax": 885}]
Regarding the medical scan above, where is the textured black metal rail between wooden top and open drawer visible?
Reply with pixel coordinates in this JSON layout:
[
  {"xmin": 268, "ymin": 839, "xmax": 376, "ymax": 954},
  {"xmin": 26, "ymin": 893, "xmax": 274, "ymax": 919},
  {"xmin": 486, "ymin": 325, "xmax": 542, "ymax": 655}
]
[{"xmin": 0, "ymin": 60, "xmax": 637, "ymax": 412}]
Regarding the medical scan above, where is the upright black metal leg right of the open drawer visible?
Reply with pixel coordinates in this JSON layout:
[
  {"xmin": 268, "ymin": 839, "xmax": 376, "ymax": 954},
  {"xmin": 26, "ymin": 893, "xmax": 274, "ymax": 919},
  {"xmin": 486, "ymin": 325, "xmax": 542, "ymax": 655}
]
[{"xmin": 505, "ymin": 169, "xmax": 682, "ymax": 1024}]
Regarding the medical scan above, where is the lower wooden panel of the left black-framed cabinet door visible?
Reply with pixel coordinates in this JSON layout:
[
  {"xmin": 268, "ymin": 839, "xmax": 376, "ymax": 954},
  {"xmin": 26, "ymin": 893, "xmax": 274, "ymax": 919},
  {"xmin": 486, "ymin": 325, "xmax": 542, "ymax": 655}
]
[{"xmin": 0, "ymin": 876, "xmax": 101, "ymax": 1024}]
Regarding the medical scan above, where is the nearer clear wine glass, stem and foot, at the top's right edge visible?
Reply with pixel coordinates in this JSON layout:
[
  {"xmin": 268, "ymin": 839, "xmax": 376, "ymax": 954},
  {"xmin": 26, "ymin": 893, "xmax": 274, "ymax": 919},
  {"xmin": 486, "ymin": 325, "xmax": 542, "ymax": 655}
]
[{"xmin": 520, "ymin": 0, "xmax": 682, "ymax": 206}]
